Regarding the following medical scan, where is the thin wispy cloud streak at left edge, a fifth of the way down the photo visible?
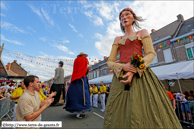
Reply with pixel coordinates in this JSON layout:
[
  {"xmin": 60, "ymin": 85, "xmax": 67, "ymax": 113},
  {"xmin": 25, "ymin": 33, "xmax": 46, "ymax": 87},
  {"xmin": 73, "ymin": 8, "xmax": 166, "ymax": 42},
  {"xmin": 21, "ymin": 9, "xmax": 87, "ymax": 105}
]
[{"xmin": 1, "ymin": 22, "xmax": 26, "ymax": 33}]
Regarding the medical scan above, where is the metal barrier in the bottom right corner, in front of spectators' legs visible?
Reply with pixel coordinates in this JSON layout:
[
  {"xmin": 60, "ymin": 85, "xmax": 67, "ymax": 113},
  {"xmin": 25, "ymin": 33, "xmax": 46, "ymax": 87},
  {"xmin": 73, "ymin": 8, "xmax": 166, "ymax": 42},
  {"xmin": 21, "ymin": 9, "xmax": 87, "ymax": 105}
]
[{"xmin": 175, "ymin": 100, "xmax": 194, "ymax": 126}]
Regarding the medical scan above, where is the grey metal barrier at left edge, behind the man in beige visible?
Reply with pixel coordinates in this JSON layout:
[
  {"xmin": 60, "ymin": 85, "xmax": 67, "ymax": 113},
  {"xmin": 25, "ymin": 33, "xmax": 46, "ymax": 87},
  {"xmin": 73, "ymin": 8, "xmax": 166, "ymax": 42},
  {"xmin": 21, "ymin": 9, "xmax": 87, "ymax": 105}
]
[{"xmin": 0, "ymin": 98, "xmax": 11, "ymax": 120}]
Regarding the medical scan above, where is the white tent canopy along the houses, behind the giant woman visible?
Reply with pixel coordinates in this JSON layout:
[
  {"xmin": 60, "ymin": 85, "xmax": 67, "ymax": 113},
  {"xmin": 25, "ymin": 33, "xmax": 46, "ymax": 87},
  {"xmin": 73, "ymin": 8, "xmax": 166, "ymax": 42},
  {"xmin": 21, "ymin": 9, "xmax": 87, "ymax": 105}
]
[{"xmin": 89, "ymin": 60, "xmax": 194, "ymax": 84}]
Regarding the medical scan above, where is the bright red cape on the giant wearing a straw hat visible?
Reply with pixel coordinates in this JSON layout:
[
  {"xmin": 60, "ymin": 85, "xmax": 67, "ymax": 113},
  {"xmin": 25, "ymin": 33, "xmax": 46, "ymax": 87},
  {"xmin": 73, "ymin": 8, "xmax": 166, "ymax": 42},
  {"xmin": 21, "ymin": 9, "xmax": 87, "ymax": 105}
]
[{"xmin": 71, "ymin": 56, "xmax": 88, "ymax": 82}]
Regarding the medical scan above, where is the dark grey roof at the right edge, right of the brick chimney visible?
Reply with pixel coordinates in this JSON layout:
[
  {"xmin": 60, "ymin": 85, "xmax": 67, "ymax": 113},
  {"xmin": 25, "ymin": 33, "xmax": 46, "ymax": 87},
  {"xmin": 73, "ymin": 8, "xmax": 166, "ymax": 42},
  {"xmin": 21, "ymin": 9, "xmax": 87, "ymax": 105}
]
[{"xmin": 176, "ymin": 17, "xmax": 194, "ymax": 37}]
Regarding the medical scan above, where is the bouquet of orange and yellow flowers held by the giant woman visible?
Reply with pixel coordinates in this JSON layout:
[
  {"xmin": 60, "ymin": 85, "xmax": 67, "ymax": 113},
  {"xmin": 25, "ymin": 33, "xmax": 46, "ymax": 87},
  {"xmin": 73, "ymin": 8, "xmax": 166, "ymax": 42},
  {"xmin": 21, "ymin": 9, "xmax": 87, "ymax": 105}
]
[{"xmin": 130, "ymin": 53, "xmax": 145, "ymax": 69}]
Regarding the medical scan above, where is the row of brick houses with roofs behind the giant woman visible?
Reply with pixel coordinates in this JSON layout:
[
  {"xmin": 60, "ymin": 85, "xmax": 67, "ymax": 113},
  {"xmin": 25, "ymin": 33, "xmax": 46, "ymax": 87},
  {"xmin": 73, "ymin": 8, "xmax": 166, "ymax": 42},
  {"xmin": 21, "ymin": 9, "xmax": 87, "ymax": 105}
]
[{"xmin": 88, "ymin": 14, "xmax": 194, "ymax": 80}]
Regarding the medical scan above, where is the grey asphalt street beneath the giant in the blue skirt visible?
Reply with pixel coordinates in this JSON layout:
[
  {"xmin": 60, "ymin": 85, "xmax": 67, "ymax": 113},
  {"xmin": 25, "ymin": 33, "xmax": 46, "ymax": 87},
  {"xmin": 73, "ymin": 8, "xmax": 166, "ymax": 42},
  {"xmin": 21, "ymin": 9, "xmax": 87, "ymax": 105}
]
[{"xmin": 0, "ymin": 104, "xmax": 192, "ymax": 129}]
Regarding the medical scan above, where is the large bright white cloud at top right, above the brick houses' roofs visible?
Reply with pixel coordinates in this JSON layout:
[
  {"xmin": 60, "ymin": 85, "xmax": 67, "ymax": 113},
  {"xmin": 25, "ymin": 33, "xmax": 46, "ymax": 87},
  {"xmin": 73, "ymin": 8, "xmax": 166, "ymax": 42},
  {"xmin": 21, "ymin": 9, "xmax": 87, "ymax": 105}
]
[{"xmin": 132, "ymin": 1, "xmax": 193, "ymax": 32}]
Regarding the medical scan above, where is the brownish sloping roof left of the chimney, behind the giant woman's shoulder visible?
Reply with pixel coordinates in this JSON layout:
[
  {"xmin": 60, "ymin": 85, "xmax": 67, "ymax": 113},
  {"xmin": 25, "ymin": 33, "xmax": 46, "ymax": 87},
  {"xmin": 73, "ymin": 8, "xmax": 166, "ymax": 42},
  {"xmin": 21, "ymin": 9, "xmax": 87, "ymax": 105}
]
[{"xmin": 151, "ymin": 20, "xmax": 181, "ymax": 42}]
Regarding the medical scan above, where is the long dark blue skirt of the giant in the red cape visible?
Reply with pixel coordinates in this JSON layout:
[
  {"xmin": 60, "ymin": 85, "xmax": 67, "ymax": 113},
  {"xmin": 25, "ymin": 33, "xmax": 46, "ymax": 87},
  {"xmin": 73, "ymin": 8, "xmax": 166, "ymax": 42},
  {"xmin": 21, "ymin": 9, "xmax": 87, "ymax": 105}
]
[{"xmin": 64, "ymin": 77, "xmax": 91, "ymax": 113}]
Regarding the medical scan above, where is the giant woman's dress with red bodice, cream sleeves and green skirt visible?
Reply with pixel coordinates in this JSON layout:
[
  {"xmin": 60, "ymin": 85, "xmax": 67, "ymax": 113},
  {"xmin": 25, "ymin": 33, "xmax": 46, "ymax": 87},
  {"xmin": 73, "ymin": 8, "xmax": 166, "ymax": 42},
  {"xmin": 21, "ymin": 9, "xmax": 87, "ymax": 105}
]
[{"xmin": 103, "ymin": 36, "xmax": 182, "ymax": 129}]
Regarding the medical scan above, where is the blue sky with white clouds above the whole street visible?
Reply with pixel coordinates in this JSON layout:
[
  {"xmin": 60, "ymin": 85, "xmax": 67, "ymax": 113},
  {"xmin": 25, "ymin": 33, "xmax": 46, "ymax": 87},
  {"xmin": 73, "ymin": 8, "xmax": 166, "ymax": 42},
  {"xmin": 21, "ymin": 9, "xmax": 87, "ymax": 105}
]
[{"xmin": 0, "ymin": 1, "xmax": 193, "ymax": 81}]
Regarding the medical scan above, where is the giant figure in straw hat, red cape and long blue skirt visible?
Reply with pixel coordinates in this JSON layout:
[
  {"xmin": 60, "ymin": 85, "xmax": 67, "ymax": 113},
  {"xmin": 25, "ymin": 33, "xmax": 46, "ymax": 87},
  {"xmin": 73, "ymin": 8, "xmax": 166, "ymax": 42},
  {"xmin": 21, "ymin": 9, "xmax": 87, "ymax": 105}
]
[{"xmin": 64, "ymin": 52, "xmax": 91, "ymax": 118}]
